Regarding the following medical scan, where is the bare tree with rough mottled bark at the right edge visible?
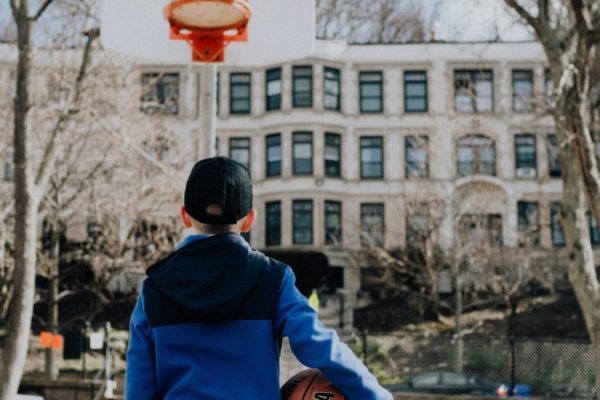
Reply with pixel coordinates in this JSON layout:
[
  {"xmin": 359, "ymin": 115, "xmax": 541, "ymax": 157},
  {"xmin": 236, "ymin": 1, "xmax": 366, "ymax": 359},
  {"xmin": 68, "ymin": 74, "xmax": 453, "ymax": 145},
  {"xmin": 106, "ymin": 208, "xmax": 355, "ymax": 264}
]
[{"xmin": 505, "ymin": 0, "xmax": 600, "ymax": 393}]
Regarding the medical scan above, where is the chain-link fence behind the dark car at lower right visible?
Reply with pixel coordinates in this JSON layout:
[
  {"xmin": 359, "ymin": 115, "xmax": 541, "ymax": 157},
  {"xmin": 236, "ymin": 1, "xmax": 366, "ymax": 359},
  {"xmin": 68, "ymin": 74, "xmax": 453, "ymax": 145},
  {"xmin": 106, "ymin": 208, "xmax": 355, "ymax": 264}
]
[{"xmin": 349, "ymin": 332, "xmax": 595, "ymax": 398}]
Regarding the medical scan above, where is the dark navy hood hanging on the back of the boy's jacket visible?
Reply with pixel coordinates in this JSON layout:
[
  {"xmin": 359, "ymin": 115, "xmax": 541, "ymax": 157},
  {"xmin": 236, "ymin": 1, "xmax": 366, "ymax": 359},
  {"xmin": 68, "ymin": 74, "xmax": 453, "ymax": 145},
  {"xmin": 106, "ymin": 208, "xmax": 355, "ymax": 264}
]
[{"xmin": 147, "ymin": 233, "xmax": 264, "ymax": 320}]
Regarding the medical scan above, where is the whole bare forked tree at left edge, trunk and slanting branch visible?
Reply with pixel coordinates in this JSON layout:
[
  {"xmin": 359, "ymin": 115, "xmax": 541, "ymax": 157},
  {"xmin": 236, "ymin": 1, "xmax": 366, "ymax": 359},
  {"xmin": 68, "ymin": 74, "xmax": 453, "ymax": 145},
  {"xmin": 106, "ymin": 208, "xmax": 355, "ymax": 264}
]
[{"xmin": 0, "ymin": 0, "xmax": 99, "ymax": 394}]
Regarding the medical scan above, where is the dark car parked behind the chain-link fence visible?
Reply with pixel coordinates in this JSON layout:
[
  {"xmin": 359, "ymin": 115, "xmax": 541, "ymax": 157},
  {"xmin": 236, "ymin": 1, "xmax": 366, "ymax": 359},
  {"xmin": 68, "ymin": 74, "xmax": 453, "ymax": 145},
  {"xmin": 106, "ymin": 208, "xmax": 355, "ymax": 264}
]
[{"xmin": 388, "ymin": 372, "xmax": 500, "ymax": 396}]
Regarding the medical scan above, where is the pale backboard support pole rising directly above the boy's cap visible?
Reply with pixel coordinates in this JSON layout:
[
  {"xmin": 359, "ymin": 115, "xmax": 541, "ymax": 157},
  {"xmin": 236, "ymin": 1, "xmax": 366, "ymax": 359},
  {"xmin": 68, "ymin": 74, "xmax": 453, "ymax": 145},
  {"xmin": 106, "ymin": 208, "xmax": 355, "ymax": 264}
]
[{"xmin": 198, "ymin": 64, "xmax": 217, "ymax": 159}]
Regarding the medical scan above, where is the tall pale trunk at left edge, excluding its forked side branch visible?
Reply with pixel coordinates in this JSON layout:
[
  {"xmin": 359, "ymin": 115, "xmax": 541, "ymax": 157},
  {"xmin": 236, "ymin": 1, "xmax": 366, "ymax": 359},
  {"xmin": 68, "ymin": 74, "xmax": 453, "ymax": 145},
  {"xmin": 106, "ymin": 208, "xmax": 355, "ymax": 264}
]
[{"xmin": 0, "ymin": 1, "xmax": 37, "ymax": 400}]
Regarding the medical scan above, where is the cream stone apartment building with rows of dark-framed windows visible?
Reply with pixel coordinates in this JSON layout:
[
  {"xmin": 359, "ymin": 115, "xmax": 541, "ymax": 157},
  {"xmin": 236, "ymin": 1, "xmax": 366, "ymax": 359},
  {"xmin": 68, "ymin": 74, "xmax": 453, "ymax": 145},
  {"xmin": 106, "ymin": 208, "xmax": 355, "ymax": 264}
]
[{"xmin": 4, "ymin": 41, "xmax": 584, "ymax": 328}]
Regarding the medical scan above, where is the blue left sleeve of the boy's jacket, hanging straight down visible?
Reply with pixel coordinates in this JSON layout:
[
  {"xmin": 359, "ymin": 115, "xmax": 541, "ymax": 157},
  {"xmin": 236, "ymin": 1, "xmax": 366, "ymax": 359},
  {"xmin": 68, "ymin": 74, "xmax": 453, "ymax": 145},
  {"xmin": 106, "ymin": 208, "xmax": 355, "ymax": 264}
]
[{"xmin": 125, "ymin": 289, "xmax": 160, "ymax": 400}]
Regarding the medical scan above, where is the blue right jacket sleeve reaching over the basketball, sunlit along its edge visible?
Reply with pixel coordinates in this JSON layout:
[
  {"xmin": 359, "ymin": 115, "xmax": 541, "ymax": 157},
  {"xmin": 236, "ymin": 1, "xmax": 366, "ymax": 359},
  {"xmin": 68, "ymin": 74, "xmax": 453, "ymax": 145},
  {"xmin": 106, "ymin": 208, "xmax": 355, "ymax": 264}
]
[{"xmin": 275, "ymin": 268, "xmax": 393, "ymax": 400}]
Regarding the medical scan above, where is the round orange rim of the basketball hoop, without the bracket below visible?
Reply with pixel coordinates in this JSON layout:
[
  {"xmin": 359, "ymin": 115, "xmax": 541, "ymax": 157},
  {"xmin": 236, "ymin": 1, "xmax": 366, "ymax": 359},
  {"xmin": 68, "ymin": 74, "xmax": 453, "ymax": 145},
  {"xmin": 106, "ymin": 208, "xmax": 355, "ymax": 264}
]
[{"xmin": 164, "ymin": 0, "xmax": 252, "ymax": 34}]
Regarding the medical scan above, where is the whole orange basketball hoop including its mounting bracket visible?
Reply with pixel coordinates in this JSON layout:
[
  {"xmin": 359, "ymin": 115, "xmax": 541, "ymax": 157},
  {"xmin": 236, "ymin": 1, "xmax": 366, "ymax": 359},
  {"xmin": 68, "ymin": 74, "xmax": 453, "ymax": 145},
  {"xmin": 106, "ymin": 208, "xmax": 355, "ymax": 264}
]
[{"xmin": 164, "ymin": 0, "xmax": 252, "ymax": 62}]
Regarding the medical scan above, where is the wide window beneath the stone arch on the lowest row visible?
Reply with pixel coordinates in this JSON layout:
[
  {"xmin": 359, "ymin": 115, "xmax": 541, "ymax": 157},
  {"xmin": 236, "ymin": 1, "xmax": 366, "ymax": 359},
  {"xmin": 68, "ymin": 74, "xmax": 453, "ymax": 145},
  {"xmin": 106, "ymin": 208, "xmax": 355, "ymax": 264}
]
[{"xmin": 460, "ymin": 214, "xmax": 503, "ymax": 247}]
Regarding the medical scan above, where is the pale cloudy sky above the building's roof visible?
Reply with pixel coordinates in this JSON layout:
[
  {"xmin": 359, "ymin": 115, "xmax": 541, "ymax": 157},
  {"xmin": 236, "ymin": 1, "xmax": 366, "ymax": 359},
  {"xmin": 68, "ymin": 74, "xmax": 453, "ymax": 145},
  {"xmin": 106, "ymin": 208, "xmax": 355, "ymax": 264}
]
[{"xmin": 0, "ymin": 0, "xmax": 532, "ymax": 41}]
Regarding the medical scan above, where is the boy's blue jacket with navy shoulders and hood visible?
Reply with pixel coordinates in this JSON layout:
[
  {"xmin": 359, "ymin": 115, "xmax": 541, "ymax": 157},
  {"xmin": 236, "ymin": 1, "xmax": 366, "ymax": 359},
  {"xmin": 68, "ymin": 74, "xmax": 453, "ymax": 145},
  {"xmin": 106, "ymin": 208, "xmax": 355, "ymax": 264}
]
[{"xmin": 125, "ymin": 234, "xmax": 392, "ymax": 400}]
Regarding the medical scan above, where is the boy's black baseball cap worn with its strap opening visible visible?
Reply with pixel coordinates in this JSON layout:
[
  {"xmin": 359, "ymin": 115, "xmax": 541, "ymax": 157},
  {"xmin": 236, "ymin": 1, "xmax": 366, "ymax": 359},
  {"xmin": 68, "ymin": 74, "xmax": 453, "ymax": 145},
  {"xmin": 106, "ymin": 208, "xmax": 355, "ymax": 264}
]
[{"xmin": 184, "ymin": 157, "xmax": 252, "ymax": 225}]
